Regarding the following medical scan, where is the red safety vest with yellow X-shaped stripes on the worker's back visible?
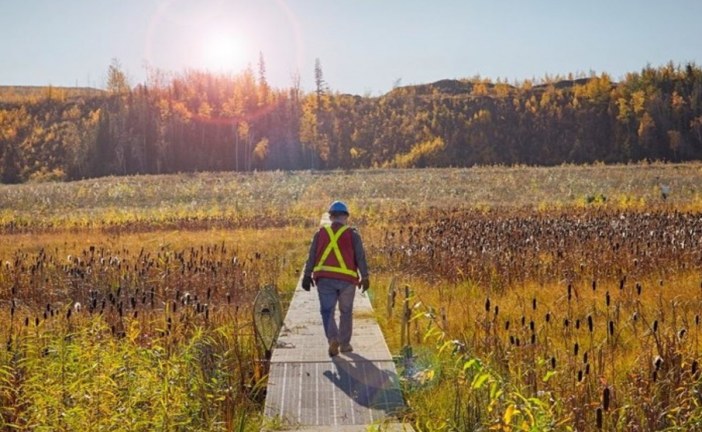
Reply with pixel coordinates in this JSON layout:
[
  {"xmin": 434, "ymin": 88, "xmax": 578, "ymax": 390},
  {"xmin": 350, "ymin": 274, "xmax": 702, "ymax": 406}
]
[{"xmin": 313, "ymin": 224, "xmax": 358, "ymax": 283}]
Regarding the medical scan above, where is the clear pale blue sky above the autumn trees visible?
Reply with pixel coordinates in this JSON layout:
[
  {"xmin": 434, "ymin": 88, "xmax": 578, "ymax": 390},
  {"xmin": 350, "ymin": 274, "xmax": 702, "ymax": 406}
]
[{"xmin": 0, "ymin": 0, "xmax": 702, "ymax": 95}]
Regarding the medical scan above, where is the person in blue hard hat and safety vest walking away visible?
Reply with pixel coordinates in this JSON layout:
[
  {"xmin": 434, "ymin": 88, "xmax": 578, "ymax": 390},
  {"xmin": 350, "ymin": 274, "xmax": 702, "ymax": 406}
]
[{"xmin": 302, "ymin": 201, "xmax": 370, "ymax": 357}]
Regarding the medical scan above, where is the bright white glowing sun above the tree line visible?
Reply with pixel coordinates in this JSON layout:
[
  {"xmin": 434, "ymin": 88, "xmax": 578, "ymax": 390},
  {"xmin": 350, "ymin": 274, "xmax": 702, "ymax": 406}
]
[{"xmin": 202, "ymin": 32, "xmax": 246, "ymax": 72}]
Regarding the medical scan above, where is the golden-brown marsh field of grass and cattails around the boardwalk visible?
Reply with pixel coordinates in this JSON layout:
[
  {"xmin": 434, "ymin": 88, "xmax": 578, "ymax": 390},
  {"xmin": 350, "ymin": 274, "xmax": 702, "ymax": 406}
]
[{"xmin": 0, "ymin": 164, "xmax": 702, "ymax": 431}]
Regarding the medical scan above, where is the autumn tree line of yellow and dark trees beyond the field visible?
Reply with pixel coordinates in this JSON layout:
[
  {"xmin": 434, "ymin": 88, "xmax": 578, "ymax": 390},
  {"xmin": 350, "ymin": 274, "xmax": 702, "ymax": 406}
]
[{"xmin": 0, "ymin": 57, "xmax": 702, "ymax": 183}]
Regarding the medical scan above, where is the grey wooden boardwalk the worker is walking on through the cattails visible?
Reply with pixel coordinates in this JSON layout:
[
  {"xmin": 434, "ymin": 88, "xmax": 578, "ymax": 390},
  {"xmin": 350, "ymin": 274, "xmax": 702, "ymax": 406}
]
[{"xmin": 264, "ymin": 270, "xmax": 413, "ymax": 431}]
